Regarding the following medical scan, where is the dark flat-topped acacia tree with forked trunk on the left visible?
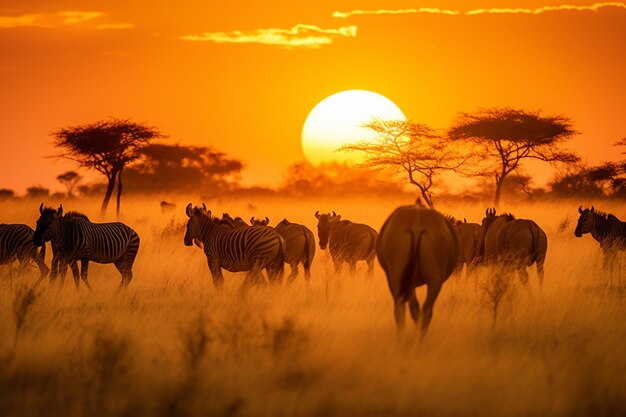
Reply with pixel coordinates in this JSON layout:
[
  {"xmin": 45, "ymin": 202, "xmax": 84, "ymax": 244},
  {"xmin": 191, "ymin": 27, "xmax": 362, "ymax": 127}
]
[{"xmin": 52, "ymin": 118, "xmax": 163, "ymax": 216}]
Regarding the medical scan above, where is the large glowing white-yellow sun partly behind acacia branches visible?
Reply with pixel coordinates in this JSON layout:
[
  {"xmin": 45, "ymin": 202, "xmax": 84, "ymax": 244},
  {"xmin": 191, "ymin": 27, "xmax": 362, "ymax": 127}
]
[{"xmin": 302, "ymin": 90, "xmax": 406, "ymax": 164}]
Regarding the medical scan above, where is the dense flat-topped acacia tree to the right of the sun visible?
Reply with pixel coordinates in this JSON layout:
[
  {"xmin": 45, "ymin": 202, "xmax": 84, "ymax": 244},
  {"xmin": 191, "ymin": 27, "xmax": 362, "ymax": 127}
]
[{"xmin": 448, "ymin": 108, "xmax": 580, "ymax": 207}]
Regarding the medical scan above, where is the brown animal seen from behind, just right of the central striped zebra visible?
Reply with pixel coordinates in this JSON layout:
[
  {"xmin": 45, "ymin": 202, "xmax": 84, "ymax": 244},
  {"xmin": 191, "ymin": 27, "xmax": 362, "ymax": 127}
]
[{"xmin": 250, "ymin": 217, "xmax": 315, "ymax": 284}]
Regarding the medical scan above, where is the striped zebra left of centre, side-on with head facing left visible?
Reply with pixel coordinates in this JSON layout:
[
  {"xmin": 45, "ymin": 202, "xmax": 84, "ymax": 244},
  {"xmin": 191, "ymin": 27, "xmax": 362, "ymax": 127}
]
[{"xmin": 184, "ymin": 203, "xmax": 285, "ymax": 289}]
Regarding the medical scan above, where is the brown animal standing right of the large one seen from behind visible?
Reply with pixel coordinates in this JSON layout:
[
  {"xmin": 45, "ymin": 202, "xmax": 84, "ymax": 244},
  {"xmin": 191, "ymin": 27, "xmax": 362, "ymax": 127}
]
[{"xmin": 482, "ymin": 209, "xmax": 548, "ymax": 285}]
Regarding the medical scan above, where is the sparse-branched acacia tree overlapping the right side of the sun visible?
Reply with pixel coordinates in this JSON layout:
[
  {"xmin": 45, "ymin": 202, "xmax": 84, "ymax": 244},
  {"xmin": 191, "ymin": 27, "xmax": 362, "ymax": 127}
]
[{"xmin": 339, "ymin": 119, "xmax": 471, "ymax": 207}]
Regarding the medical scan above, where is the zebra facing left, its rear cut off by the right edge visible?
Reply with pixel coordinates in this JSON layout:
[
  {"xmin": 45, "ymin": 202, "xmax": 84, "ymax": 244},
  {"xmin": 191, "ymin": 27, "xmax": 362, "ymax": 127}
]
[{"xmin": 574, "ymin": 206, "xmax": 626, "ymax": 270}]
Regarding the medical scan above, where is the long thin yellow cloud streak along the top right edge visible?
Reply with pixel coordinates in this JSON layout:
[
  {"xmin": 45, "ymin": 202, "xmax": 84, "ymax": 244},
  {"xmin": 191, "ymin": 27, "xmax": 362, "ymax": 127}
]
[{"xmin": 333, "ymin": 1, "xmax": 626, "ymax": 19}]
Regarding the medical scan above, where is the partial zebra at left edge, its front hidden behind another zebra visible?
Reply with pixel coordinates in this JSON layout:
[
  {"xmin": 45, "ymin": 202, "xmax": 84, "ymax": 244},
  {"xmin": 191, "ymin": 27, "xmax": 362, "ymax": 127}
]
[{"xmin": 0, "ymin": 224, "xmax": 50, "ymax": 283}]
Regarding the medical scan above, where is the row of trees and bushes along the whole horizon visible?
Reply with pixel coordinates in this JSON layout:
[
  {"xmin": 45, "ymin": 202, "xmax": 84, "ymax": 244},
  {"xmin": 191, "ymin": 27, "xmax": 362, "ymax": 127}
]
[{"xmin": 0, "ymin": 112, "xmax": 626, "ymax": 208}]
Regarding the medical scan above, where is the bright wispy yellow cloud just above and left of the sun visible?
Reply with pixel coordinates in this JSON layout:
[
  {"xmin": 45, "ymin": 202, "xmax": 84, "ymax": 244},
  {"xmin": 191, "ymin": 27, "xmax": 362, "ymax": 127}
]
[{"xmin": 179, "ymin": 24, "xmax": 357, "ymax": 48}]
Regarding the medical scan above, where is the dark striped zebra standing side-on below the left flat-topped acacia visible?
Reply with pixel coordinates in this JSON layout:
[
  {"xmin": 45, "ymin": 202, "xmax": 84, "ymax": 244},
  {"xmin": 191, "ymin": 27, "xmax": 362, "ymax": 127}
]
[{"xmin": 33, "ymin": 203, "xmax": 139, "ymax": 289}]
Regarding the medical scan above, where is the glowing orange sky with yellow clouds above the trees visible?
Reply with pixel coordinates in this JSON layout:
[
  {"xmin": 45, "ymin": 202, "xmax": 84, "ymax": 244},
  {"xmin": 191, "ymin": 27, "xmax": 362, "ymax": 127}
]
[{"xmin": 0, "ymin": 0, "xmax": 626, "ymax": 191}]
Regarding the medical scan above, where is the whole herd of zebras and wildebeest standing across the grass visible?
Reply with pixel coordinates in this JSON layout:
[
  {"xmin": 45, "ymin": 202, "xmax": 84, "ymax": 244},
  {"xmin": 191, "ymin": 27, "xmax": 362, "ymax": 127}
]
[{"xmin": 0, "ymin": 201, "xmax": 626, "ymax": 335}]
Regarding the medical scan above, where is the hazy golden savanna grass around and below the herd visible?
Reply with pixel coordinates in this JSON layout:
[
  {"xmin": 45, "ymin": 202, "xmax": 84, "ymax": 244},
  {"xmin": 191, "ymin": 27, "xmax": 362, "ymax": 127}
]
[{"xmin": 0, "ymin": 198, "xmax": 626, "ymax": 417}]
